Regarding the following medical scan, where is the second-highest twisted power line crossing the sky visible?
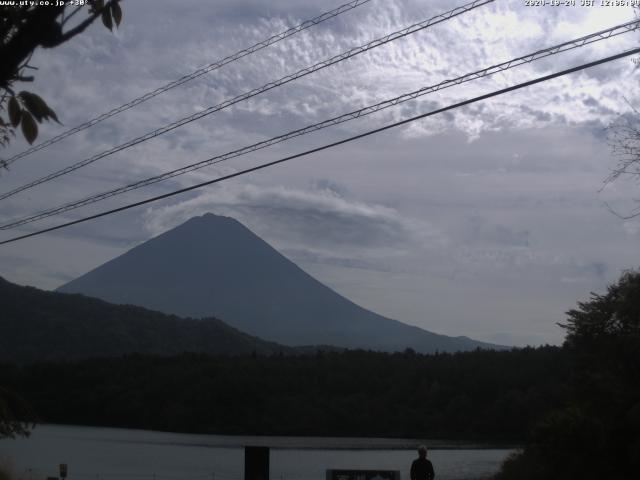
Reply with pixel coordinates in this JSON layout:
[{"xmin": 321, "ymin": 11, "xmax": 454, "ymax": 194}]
[{"xmin": 0, "ymin": 0, "xmax": 495, "ymax": 200}]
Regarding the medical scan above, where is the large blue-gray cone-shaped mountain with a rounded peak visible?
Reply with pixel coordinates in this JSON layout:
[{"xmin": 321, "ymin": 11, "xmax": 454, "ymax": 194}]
[{"xmin": 58, "ymin": 213, "xmax": 501, "ymax": 353}]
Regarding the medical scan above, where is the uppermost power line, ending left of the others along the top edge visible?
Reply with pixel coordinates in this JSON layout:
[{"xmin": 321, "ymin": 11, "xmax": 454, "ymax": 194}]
[{"xmin": 5, "ymin": 0, "xmax": 371, "ymax": 166}]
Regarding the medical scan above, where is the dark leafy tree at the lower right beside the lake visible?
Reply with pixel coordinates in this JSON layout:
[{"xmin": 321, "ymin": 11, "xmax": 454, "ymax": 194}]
[{"xmin": 498, "ymin": 271, "xmax": 640, "ymax": 480}]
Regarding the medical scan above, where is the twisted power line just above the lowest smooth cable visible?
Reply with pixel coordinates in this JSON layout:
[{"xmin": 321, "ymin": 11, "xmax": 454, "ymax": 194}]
[{"xmin": 0, "ymin": 20, "xmax": 640, "ymax": 230}]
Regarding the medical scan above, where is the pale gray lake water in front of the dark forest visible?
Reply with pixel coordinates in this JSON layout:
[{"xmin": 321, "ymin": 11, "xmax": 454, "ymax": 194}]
[{"xmin": 0, "ymin": 425, "xmax": 512, "ymax": 480}]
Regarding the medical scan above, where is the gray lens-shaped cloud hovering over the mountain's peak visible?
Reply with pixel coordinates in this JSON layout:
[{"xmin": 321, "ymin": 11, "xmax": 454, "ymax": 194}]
[{"xmin": 146, "ymin": 179, "xmax": 442, "ymax": 255}]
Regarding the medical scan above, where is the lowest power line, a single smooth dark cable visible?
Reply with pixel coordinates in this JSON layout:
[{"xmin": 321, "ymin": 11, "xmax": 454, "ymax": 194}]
[{"xmin": 0, "ymin": 48, "xmax": 640, "ymax": 245}]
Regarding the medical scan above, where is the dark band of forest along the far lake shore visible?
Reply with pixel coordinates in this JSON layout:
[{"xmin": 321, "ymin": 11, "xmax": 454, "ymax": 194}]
[{"xmin": 0, "ymin": 347, "xmax": 568, "ymax": 441}]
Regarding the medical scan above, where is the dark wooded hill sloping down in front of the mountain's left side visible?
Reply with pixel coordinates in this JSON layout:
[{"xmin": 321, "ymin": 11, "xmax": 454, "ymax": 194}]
[{"xmin": 0, "ymin": 278, "xmax": 292, "ymax": 363}]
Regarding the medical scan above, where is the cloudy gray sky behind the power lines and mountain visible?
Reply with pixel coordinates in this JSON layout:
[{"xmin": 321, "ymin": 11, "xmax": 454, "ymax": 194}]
[{"xmin": 0, "ymin": 0, "xmax": 640, "ymax": 345}]
